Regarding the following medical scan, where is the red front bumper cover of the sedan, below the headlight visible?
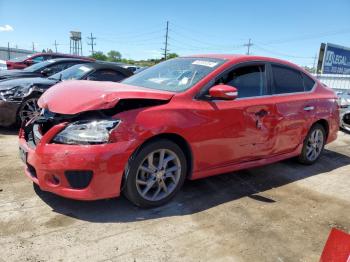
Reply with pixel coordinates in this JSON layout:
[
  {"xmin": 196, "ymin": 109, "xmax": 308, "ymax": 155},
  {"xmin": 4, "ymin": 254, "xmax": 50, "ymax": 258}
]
[{"xmin": 19, "ymin": 124, "xmax": 137, "ymax": 200}]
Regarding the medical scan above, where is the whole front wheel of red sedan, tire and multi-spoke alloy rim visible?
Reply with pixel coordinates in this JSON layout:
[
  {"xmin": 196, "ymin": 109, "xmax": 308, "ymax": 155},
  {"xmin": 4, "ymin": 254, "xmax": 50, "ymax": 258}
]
[{"xmin": 123, "ymin": 139, "xmax": 187, "ymax": 208}]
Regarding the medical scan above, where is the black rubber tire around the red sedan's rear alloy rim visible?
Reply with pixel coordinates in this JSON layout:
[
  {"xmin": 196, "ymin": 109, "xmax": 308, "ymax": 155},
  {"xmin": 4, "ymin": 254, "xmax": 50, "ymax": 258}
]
[{"xmin": 298, "ymin": 124, "xmax": 327, "ymax": 165}]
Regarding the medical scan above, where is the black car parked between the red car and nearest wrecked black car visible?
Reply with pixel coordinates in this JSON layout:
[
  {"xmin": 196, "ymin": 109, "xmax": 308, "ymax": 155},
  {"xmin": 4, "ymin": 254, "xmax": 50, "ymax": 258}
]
[{"xmin": 0, "ymin": 58, "xmax": 92, "ymax": 81}]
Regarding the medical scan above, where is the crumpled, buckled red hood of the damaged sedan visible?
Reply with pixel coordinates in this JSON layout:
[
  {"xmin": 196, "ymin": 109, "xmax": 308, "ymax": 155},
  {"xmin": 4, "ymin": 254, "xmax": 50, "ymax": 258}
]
[{"xmin": 38, "ymin": 80, "xmax": 175, "ymax": 115}]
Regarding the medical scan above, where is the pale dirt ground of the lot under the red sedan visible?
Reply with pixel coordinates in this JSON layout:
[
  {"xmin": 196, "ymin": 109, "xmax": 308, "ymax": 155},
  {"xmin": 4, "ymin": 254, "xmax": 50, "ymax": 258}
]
[{"xmin": 0, "ymin": 129, "xmax": 350, "ymax": 261}]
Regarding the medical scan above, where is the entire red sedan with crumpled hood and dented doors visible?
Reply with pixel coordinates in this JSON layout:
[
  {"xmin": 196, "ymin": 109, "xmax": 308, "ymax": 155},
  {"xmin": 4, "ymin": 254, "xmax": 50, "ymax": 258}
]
[{"xmin": 20, "ymin": 55, "xmax": 339, "ymax": 207}]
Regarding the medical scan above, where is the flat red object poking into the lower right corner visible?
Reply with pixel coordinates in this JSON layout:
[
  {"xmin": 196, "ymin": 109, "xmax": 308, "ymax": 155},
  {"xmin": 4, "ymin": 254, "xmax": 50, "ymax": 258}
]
[{"xmin": 320, "ymin": 228, "xmax": 350, "ymax": 262}]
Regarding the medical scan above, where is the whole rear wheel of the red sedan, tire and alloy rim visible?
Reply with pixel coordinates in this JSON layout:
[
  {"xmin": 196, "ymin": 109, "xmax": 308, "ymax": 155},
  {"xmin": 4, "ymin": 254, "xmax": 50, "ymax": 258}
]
[{"xmin": 298, "ymin": 124, "xmax": 326, "ymax": 165}]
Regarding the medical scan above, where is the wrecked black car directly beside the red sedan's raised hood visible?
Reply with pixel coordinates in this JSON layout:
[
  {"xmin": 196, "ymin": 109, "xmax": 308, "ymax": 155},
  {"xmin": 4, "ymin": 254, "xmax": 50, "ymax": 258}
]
[{"xmin": 0, "ymin": 62, "xmax": 132, "ymax": 126}]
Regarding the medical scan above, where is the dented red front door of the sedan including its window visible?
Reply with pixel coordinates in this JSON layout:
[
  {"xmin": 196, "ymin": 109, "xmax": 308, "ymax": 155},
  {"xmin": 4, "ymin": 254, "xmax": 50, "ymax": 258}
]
[{"xmin": 194, "ymin": 63, "xmax": 276, "ymax": 168}]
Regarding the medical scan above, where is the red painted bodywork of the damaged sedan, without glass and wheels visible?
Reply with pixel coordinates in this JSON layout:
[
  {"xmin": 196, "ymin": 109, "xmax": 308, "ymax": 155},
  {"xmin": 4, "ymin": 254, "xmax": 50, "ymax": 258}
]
[{"xmin": 20, "ymin": 55, "xmax": 339, "ymax": 200}]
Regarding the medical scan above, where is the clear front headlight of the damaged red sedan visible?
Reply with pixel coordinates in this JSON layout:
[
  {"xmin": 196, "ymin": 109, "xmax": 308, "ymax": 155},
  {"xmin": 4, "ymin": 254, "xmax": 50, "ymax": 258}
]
[{"xmin": 53, "ymin": 120, "xmax": 120, "ymax": 145}]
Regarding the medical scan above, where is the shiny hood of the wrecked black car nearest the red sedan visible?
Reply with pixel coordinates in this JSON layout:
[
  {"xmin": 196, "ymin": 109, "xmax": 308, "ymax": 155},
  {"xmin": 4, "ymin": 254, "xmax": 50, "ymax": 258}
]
[{"xmin": 0, "ymin": 77, "xmax": 57, "ymax": 91}]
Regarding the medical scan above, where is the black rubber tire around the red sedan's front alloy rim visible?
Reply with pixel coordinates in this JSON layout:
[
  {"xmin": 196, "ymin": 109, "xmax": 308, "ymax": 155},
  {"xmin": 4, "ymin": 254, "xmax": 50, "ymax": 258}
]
[{"xmin": 123, "ymin": 139, "xmax": 187, "ymax": 208}]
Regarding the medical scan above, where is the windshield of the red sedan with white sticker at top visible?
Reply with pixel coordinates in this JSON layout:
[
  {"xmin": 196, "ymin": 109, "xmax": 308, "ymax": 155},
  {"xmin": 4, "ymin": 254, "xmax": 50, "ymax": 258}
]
[{"xmin": 122, "ymin": 57, "xmax": 225, "ymax": 92}]
